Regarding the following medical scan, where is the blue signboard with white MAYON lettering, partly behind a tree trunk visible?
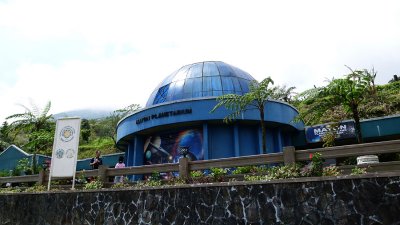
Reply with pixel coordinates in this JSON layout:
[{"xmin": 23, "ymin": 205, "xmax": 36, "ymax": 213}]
[{"xmin": 305, "ymin": 121, "xmax": 356, "ymax": 143}]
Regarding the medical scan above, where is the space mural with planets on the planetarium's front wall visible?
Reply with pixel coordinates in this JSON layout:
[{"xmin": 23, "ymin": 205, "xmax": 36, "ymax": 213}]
[{"xmin": 144, "ymin": 129, "xmax": 204, "ymax": 165}]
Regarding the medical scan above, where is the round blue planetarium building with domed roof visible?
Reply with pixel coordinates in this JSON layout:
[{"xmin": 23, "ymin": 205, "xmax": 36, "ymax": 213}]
[{"xmin": 117, "ymin": 61, "xmax": 304, "ymax": 166}]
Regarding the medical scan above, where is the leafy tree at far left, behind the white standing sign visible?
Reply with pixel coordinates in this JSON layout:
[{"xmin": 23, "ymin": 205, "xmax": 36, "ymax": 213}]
[{"xmin": 6, "ymin": 101, "xmax": 54, "ymax": 171}]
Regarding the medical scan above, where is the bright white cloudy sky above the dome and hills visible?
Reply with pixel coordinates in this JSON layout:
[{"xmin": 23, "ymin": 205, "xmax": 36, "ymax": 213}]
[{"xmin": 0, "ymin": 0, "xmax": 400, "ymax": 123}]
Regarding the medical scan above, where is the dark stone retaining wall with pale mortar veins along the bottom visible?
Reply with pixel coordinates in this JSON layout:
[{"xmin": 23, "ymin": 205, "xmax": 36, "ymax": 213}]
[{"xmin": 0, "ymin": 173, "xmax": 400, "ymax": 225}]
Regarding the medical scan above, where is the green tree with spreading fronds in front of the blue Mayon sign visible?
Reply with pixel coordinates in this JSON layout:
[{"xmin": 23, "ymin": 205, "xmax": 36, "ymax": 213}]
[{"xmin": 300, "ymin": 67, "xmax": 376, "ymax": 143}]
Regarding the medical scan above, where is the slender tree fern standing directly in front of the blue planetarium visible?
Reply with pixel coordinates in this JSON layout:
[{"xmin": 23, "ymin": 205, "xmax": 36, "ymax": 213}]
[{"xmin": 211, "ymin": 77, "xmax": 274, "ymax": 153}]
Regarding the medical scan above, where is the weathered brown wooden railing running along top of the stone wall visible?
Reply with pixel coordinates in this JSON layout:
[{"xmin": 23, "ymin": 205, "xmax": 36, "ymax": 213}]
[{"xmin": 0, "ymin": 140, "xmax": 400, "ymax": 185}]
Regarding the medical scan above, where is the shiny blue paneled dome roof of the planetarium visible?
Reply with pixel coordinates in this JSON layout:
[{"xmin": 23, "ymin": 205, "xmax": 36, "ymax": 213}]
[{"xmin": 146, "ymin": 62, "xmax": 255, "ymax": 107}]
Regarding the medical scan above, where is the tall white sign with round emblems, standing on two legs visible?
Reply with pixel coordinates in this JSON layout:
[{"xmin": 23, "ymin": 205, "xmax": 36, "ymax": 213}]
[{"xmin": 47, "ymin": 118, "xmax": 81, "ymax": 190}]
